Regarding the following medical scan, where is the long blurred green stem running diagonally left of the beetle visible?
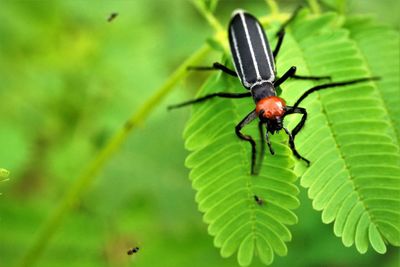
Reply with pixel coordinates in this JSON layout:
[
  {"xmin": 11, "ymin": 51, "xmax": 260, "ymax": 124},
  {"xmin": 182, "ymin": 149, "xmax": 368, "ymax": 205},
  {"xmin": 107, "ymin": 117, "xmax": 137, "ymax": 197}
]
[{"xmin": 18, "ymin": 45, "xmax": 211, "ymax": 266}]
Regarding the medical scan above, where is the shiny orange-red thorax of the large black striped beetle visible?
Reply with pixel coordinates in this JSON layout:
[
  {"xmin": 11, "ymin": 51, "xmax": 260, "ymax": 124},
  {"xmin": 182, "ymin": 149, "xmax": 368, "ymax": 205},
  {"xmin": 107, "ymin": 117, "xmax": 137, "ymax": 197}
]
[{"xmin": 256, "ymin": 96, "xmax": 286, "ymax": 120}]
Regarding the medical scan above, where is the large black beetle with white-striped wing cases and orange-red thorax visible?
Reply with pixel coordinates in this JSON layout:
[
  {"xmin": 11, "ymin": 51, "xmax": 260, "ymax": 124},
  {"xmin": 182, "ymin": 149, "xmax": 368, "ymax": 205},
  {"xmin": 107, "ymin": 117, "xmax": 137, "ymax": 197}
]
[{"xmin": 168, "ymin": 8, "xmax": 379, "ymax": 175}]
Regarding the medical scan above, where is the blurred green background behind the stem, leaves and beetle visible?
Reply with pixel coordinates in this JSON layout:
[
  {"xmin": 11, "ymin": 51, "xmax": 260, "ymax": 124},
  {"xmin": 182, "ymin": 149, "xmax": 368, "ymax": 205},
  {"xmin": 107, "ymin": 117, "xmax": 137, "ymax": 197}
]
[{"xmin": 0, "ymin": 0, "xmax": 399, "ymax": 267}]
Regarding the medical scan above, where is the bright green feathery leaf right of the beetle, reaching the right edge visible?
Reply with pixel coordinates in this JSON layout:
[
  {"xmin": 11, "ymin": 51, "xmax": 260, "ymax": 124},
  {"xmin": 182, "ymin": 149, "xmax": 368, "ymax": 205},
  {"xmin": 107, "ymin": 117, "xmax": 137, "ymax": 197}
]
[{"xmin": 278, "ymin": 14, "xmax": 400, "ymax": 253}]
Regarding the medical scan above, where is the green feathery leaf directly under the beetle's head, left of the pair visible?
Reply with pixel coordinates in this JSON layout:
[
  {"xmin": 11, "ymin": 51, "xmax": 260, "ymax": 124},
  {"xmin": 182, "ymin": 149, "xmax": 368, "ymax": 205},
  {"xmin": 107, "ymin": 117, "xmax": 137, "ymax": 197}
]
[{"xmin": 184, "ymin": 75, "xmax": 299, "ymax": 266}]
